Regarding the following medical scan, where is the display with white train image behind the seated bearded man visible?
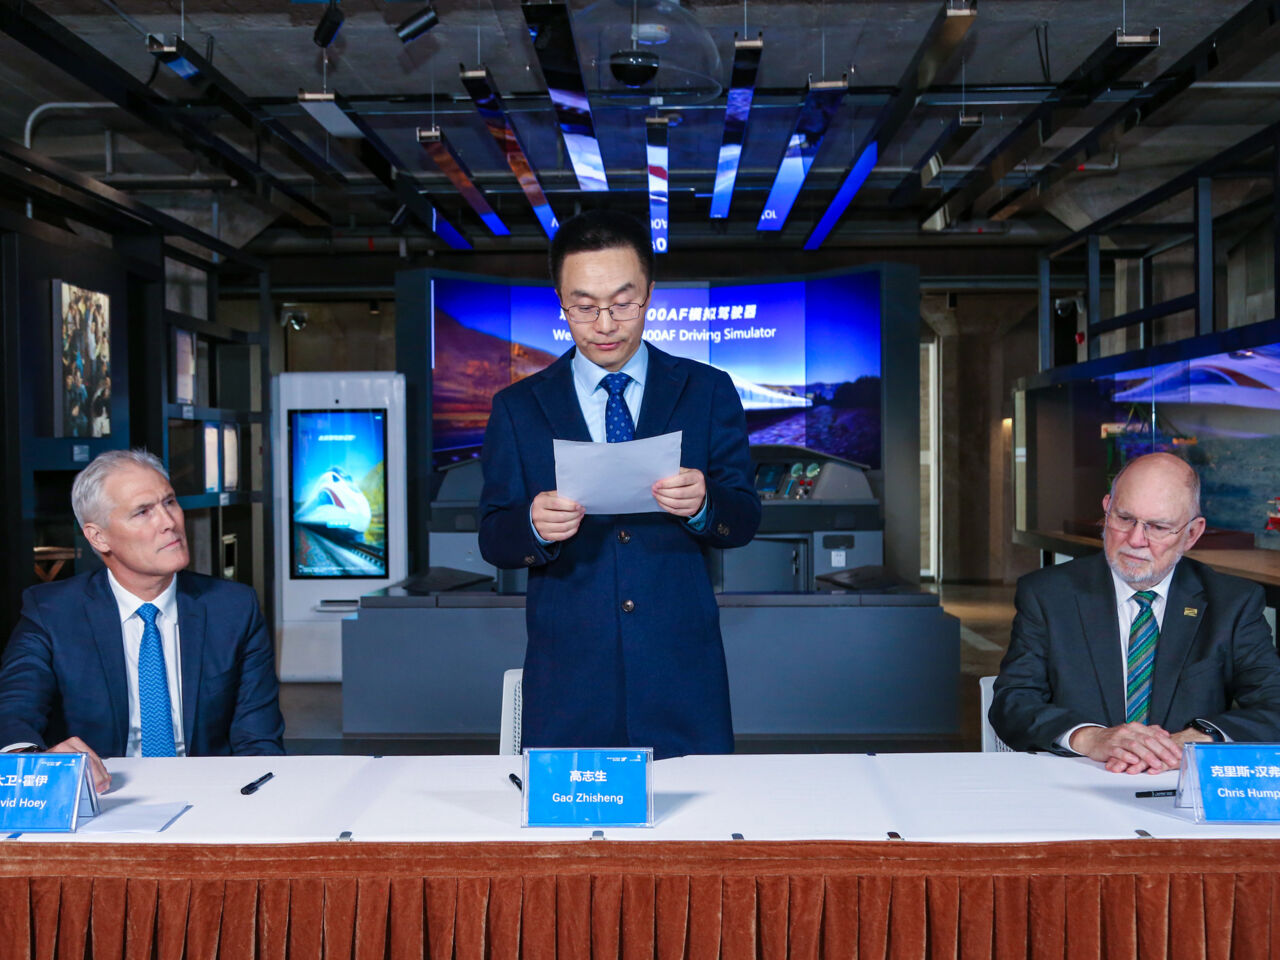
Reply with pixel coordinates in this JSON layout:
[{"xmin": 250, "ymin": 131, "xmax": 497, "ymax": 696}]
[{"xmin": 1102, "ymin": 344, "xmax": 1280, "ymax": 534}]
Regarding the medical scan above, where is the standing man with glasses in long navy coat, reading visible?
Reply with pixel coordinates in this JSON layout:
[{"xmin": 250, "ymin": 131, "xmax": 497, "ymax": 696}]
[{"xmin": 480, "ymin": 210, "xmax": 760, "ymax": 759}]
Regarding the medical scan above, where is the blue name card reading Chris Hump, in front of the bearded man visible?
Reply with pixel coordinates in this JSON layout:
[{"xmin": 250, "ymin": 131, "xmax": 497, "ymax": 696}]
[{"xmin": 1178, "ymin": 744, "xmax": 1280, "ymax": 823}]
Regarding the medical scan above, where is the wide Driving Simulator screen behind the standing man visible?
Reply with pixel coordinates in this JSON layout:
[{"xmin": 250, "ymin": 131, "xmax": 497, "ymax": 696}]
[{"xmin": 431, "ymin": 271, "xmax": 881, "ymax": 467}]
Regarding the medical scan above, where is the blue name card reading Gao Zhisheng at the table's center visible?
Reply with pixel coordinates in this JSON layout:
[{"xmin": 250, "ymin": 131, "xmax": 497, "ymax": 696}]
[{"xmin": 522, "ymin": 746, "xmax": 653, "ymax": 827}]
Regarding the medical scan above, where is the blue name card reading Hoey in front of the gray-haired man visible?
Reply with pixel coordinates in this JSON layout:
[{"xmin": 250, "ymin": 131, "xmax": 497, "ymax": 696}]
[{"xmin": 0, "ymin": 754, "xmax": 97, "ymax": 833}]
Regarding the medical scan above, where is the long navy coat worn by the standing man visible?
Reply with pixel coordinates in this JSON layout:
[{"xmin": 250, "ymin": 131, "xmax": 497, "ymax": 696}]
[{"xmin": 480, "ymin": 344, "xmax": 760, "ymax": 758}]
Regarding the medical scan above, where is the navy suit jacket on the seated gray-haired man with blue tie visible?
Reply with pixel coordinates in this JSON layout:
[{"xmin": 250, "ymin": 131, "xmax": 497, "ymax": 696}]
[{"xmin": 0, "ymin": 570, "xmax": 284, "ymax": 756}]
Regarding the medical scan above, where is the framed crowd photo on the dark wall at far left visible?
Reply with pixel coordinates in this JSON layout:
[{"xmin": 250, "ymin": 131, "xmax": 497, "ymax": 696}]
[{"xmin": 52, "ymin": 280, "xmax": 111, "ymax": 436}]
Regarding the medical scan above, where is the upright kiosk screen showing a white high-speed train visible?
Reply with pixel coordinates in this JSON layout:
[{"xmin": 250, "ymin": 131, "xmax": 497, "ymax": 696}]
[{"xmin": 289, "ymin": 410, "xmax": 387, "ymax": 579}]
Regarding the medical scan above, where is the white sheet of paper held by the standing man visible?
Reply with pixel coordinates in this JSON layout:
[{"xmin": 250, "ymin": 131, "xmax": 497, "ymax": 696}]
[{"xmin": 552, "ymin": 430, "xmax": 682, "ymax": 513}]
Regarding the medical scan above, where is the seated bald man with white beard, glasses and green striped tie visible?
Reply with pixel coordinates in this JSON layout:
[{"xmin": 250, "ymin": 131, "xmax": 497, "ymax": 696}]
[{"xmin": 989, "ymin": 453, "xmax": 1280, "ymax": 773}]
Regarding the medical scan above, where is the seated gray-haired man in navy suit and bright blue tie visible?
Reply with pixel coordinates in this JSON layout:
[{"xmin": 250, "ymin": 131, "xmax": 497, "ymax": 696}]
[{"xmin": 0, "ymin": 451, "xmax": 284, "ymax": 791}]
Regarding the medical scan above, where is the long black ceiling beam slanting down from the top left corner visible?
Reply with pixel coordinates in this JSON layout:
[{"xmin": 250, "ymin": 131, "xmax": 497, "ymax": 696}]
[{"xmin": 0, "ymin": 0, "xmax": 330, "ymax": 227}]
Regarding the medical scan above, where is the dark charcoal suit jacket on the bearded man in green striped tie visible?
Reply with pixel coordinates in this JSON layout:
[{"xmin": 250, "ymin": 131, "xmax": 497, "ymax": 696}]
[{"xmin": 988, "ymin": 553, "xmax": 1280, "ymax": 753}]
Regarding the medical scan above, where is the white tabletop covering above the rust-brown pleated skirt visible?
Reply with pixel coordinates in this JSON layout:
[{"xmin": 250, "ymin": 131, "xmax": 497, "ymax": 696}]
[{"xmin": 9, "ymin": 753, "xmax": 1280, "ymax": 844}]
